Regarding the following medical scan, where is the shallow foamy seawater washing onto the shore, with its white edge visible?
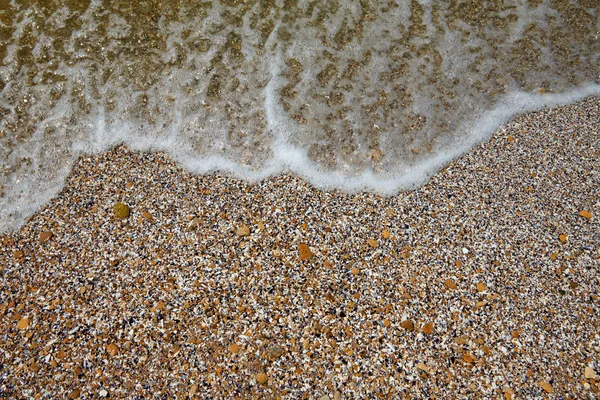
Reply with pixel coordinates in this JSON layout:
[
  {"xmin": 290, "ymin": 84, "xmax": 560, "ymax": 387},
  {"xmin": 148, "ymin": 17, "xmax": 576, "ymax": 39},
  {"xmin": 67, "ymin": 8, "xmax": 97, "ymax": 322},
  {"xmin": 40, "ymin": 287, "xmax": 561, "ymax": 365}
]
[{"xmin": 0, "ymin": 0, "xmax": 600, "ymax": 232}]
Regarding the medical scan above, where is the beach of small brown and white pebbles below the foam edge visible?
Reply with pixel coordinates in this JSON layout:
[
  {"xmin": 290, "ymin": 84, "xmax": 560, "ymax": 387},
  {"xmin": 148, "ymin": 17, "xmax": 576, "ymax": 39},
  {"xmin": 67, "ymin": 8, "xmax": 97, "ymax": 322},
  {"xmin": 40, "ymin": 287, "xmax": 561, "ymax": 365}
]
[{"xmin": 0, "ymin": 98, "xmax": 600, "ymax": 400}]
